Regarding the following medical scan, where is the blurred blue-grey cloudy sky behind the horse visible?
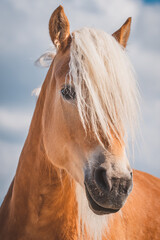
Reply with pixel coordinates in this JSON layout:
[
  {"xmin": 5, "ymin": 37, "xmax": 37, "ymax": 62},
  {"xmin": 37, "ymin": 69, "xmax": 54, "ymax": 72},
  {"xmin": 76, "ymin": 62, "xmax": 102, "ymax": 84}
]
[{"xmin": 0, "ymin": 0, "xmax": 160, "ymax": 203}]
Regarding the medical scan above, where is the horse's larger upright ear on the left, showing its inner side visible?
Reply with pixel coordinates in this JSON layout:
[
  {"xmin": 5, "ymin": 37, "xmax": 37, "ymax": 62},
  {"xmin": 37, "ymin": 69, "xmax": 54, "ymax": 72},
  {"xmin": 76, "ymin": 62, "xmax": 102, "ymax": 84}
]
[{"xmin": 49, "ymin": 5, "xmax": 70, "ymax": 49}]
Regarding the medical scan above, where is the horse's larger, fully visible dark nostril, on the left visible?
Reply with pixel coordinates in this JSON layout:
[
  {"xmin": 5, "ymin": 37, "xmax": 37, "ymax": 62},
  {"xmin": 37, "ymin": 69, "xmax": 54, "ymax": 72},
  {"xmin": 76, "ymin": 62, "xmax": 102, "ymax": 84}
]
[{"xmin": 94, "ymin": 167, "xmax": 111, "ymax": 191}]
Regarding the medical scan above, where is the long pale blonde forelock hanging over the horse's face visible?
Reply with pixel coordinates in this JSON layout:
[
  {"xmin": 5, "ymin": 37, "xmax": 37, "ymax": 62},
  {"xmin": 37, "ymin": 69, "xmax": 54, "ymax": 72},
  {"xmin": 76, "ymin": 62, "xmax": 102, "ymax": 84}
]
[{"xmin": 69, "ymin": 28, "xmax": 138, "ymax": 144}]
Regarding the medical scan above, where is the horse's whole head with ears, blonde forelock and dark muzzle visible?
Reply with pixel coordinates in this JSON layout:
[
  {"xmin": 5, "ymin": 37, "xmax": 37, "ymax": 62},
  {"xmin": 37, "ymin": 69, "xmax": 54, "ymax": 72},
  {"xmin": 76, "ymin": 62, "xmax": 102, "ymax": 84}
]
[{"xmin": 41, "ymin": 6, "xmax": 137, "ymax": 214}]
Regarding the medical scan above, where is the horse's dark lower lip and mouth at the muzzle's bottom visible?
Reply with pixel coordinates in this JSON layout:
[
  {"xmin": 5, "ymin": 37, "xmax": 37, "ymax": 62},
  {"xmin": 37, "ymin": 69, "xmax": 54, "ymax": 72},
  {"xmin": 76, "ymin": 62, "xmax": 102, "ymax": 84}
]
[{"xmin": 85, "ymin": 184, "xmax": 120, "ymax": 215}]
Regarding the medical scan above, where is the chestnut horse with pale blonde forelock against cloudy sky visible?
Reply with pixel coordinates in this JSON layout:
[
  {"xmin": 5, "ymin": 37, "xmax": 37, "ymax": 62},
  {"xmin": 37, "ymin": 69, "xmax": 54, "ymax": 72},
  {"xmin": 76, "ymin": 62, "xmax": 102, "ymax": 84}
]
[{"xmin": 0, "ymin": 6, "xmax": 160, "ymax": 240}]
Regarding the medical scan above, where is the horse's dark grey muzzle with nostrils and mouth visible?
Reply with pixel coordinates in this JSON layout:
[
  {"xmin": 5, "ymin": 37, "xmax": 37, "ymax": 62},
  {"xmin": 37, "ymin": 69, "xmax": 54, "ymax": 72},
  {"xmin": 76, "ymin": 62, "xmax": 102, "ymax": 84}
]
[{"xmin": 84, "ymin": 166, "xmax": 133, "ymax": 215}]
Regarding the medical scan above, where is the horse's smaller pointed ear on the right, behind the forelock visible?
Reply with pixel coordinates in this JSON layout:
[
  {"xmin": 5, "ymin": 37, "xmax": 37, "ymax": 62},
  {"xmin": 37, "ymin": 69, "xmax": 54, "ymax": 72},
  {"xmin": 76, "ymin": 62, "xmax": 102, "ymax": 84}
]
[{"xmin": 112, "ymin": 17, "xmax": 132, "ymax": 47}]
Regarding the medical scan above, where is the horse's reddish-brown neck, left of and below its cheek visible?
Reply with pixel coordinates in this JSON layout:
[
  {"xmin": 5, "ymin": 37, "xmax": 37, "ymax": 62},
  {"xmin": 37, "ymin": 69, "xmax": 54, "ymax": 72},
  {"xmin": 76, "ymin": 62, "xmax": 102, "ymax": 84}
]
[{"xmin": 0, "ymin": 76, "xmax": 77, "ymax": 240}]
